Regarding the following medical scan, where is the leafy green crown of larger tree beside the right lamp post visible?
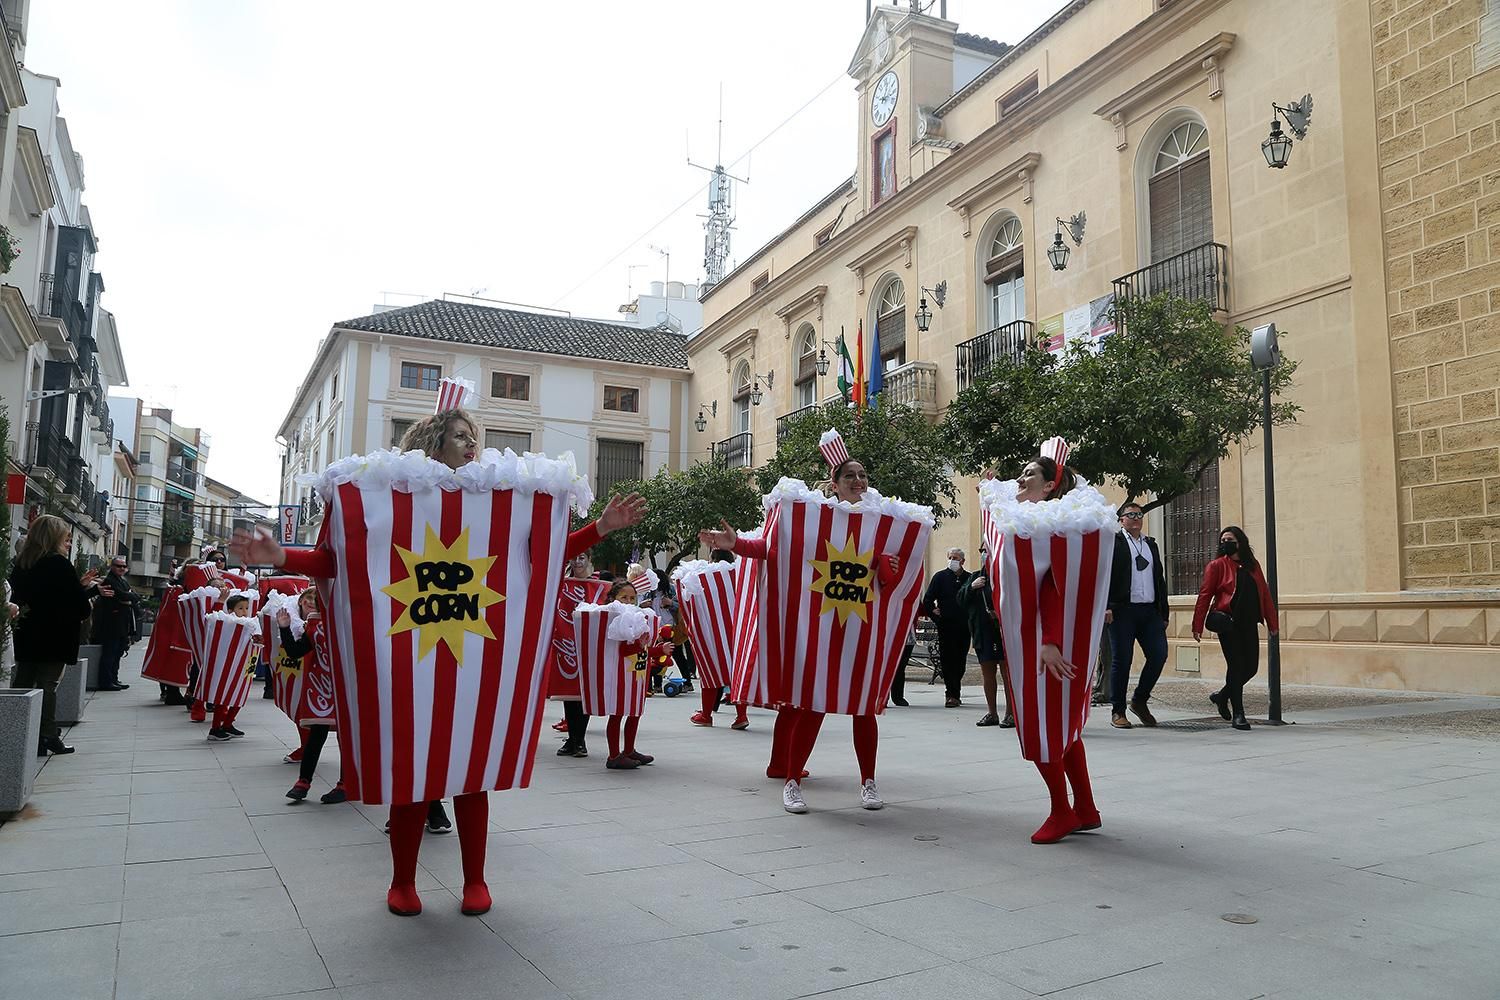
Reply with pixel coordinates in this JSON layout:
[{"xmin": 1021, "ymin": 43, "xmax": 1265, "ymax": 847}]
[{"xmin": 942, "ymin": 287, "xmax": 1301, "ymax": 510}]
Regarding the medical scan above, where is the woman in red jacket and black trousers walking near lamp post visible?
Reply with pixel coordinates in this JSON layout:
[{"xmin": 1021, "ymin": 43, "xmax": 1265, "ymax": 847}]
[{"xmin": 1193, "ymin": 525, "xmax": 1278, "ymax": 729}]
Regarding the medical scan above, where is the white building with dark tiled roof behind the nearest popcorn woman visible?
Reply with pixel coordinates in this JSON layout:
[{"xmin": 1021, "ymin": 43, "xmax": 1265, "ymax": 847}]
[{"xmin": 278, "ymin": 300, "xmax": 696, "ymax": 537}]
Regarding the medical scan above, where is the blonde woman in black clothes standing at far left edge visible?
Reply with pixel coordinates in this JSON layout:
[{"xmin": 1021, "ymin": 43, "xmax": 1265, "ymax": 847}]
[{"xmin": 11, "ymin": 514, "xmax": 99, "ymax": 757}]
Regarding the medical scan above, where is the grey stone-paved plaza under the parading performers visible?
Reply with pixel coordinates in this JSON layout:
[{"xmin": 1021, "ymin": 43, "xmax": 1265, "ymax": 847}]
[{"xmin": 0, "ymin": 648, "xmax": 1500, "ymax": 1000}]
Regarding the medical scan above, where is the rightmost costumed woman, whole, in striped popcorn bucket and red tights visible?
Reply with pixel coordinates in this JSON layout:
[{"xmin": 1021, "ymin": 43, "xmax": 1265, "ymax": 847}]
[{"xmin": 980, "ymin": 438, "xmax": 1119, "ymax": 844}]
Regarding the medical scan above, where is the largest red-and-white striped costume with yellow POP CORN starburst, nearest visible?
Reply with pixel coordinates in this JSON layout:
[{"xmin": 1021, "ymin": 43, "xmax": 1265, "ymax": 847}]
[{"xmin": 287, "ymin": 451, "xmax": 591, "ymax": 805}]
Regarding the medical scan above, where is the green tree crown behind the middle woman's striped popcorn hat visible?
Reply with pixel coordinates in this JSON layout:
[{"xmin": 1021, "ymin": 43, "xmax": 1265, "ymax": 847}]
[{"xmin": 762, "ymin": 400, "xmax": 959, "ymax": 528}]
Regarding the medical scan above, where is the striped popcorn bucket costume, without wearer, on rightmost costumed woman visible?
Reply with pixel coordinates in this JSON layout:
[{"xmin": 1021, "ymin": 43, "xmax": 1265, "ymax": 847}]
[{"xmin": 980, "ymin": 480, "xmax": 1119, "ymax": 763}]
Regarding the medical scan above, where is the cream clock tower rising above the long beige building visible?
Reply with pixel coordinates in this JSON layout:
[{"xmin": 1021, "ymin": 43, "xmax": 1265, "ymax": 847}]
[{"xmin": 849, "ymin": 3, "xmax": 959, "ymax": 211}]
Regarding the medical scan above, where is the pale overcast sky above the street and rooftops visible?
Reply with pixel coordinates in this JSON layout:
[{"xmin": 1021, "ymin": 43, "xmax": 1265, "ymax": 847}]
[{"xmin": 26, "ymin": 0, "xmax": 1062, "ymax": 502}]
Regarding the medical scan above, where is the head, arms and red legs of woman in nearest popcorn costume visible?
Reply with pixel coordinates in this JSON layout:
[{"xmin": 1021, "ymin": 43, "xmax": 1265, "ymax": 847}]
[{"xmin": 231, "ymin": 379, "xmax": 645, "ymax": 916}]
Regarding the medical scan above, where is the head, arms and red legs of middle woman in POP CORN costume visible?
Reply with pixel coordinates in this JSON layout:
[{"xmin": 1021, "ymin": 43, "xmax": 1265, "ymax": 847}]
[{"xmin": 698, "ymin": 430, "xmax": 915, "ymax": 813}]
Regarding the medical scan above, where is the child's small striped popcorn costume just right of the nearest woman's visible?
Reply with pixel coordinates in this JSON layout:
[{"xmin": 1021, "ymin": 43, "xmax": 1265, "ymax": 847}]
[{"xmin": 573, "ymin": 601, "xmax": 662, "ymax": 717}]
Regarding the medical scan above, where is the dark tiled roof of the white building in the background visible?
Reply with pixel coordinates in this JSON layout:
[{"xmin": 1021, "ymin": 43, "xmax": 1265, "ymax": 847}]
[{"xmin": 335, "ymin": 298, "xmax": 687, "ymax": 369}]
